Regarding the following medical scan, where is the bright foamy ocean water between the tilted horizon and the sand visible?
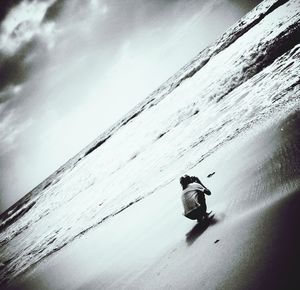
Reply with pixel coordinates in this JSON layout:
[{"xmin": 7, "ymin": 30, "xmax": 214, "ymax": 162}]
[{"xmin": 0, "ymin": 0, "xmax": 300, "ymax": 283}]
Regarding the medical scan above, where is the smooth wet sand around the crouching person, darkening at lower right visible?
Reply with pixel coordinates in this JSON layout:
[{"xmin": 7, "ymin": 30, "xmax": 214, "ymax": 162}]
[{"xmin": 6, "ymin": 112, "xmax": 300, "ymax": 290}]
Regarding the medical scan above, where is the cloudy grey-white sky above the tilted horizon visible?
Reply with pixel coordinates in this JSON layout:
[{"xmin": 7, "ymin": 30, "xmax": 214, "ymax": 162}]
[{"xmin": 0, "ymin": 0, "xmax": 260, "ymax": 212}]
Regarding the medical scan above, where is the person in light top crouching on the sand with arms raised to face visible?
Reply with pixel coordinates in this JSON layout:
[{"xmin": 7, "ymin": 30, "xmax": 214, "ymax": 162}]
[{"xmin": 180, "ymin": 174, "xmax": 211, "ymax": 221}]
